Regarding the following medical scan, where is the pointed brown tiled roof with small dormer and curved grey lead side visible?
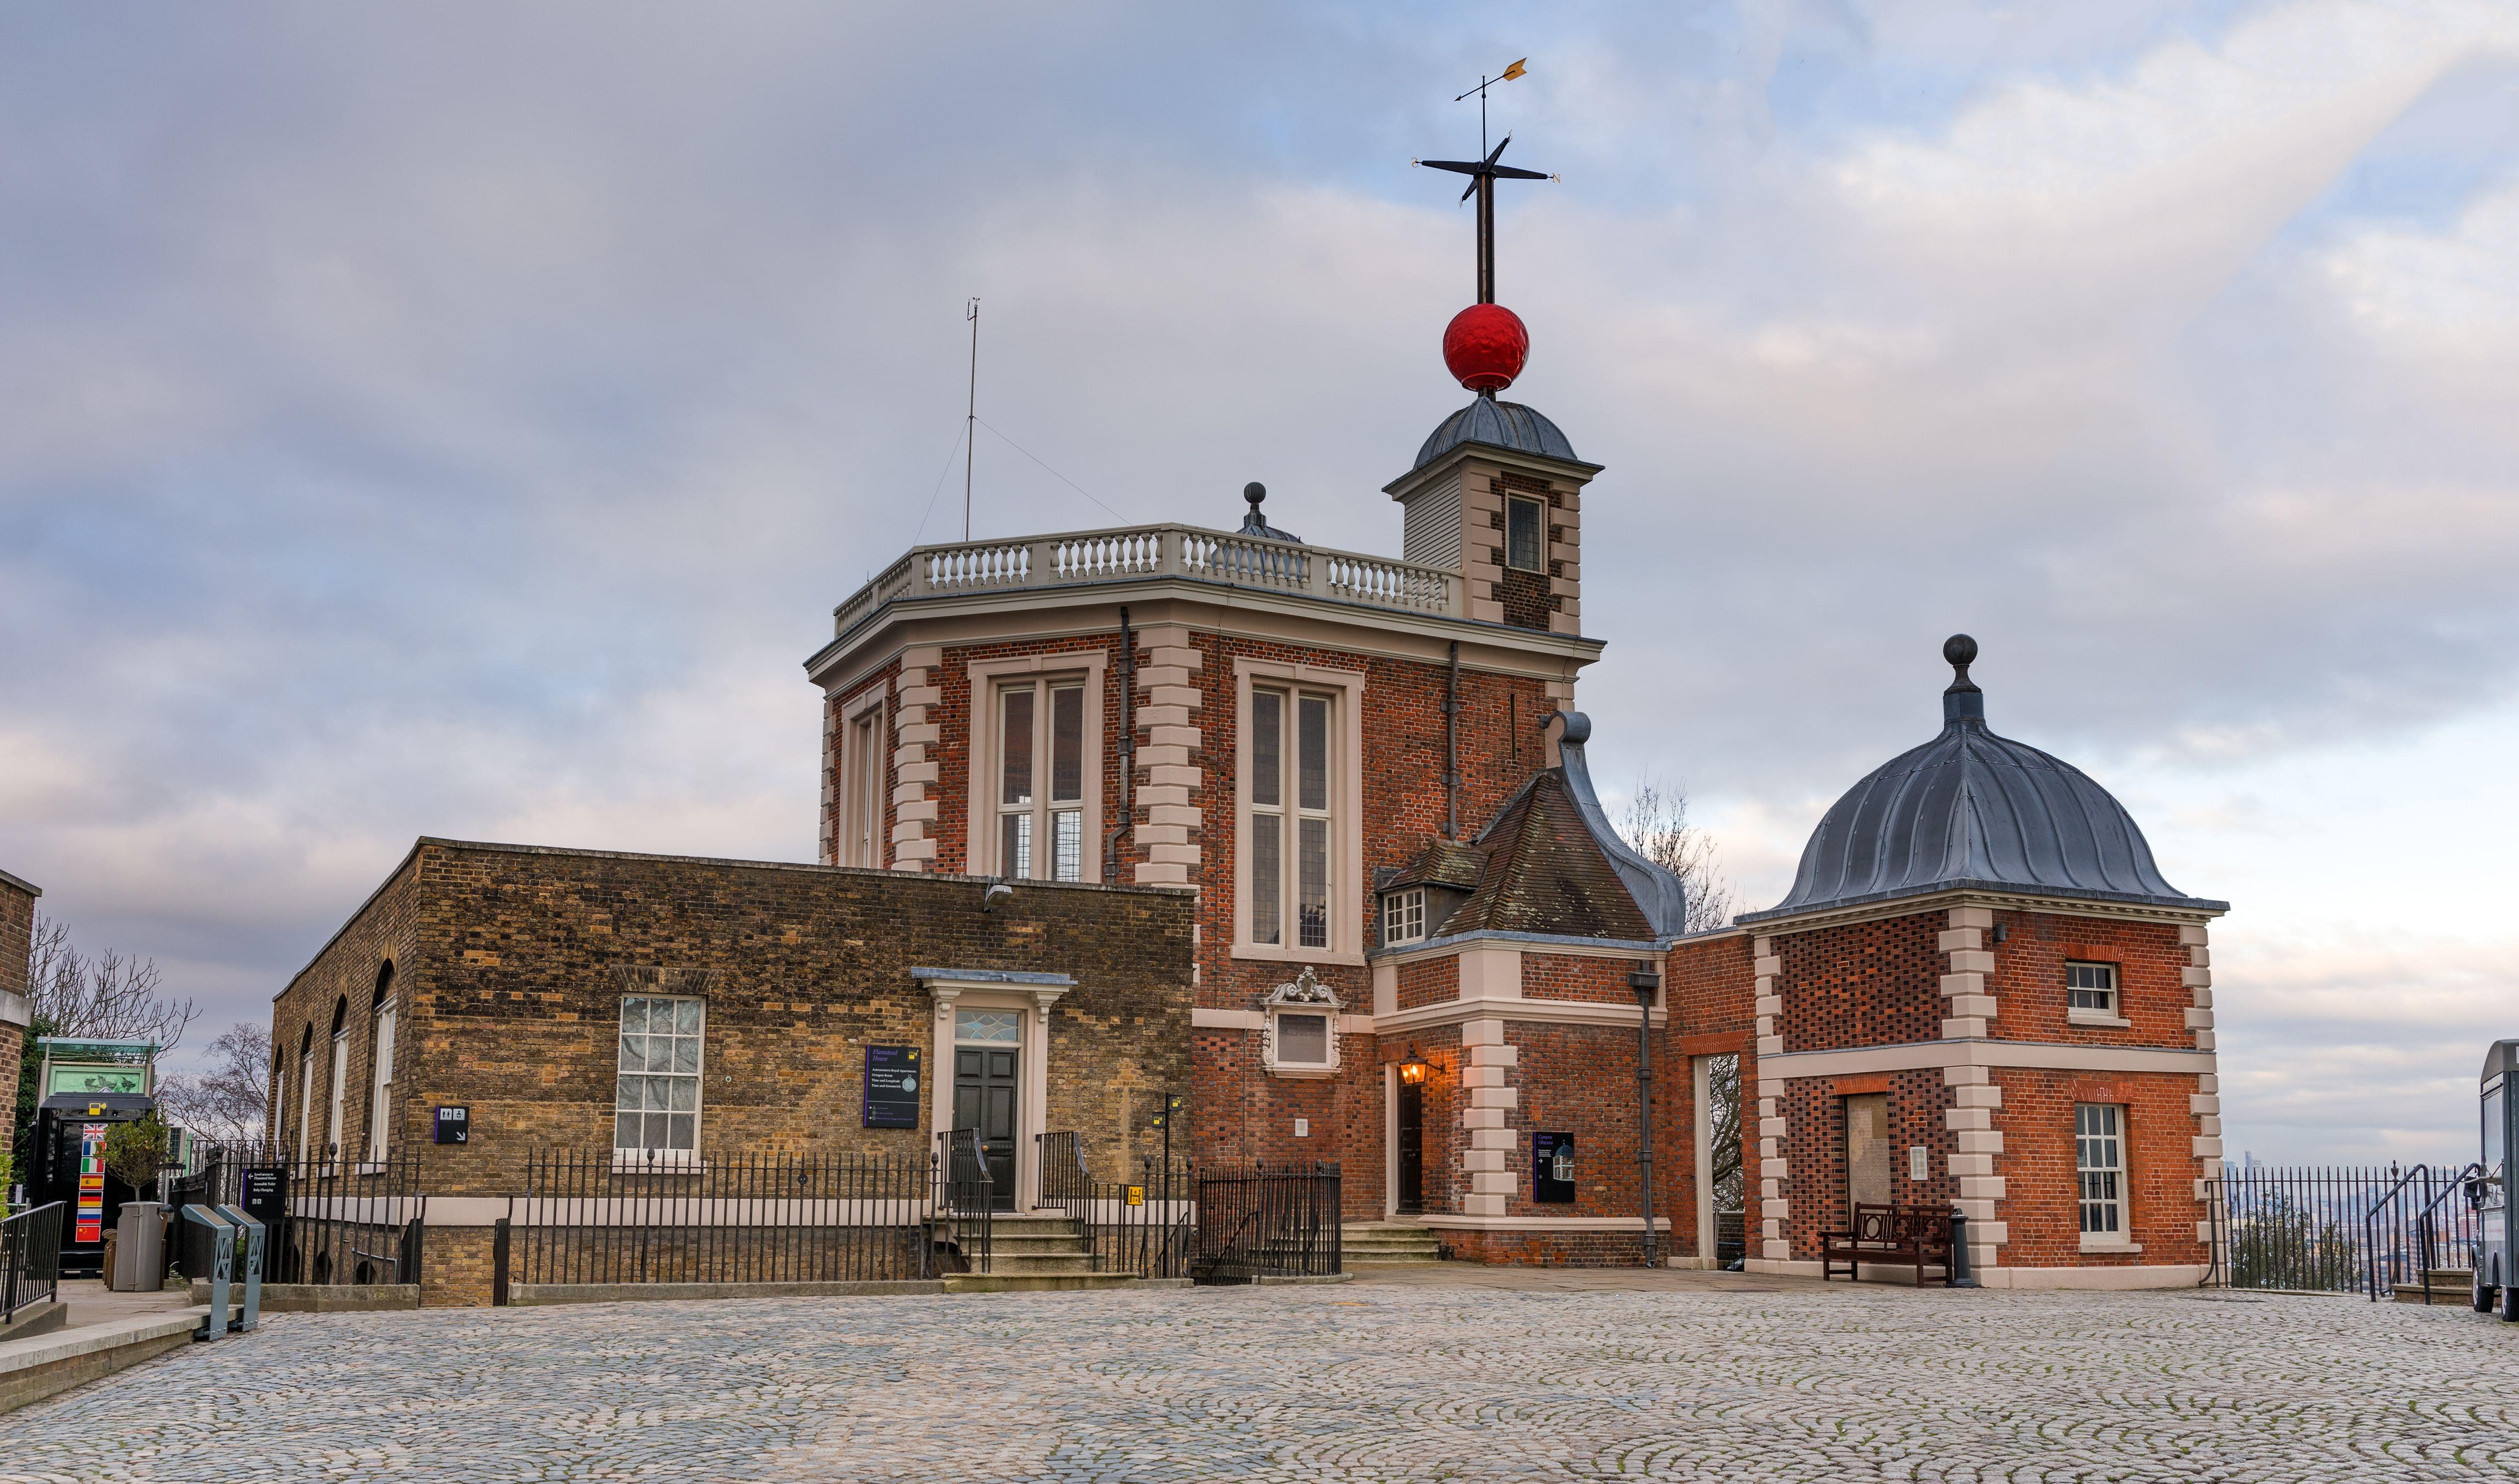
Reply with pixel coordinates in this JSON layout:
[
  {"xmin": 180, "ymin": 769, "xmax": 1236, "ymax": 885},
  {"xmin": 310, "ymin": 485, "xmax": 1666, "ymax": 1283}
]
[{"xmin": 1393, "ymin": 710, "xmax": 1685, "ymax": 942}]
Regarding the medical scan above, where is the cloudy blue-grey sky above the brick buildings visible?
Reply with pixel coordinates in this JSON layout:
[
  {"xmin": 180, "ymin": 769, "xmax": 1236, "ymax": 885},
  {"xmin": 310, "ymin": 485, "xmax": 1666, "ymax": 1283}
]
[{"xmin": 0, "ymin": 0, "xmax": 2519, "ymax": 1162}]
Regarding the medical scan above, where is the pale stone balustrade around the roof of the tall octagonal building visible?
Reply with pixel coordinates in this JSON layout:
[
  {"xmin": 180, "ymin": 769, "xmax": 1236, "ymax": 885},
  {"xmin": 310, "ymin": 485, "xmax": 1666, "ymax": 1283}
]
[{"xmin": 834, "ymin": 524, "xmax": 1469, "ymax": 637}]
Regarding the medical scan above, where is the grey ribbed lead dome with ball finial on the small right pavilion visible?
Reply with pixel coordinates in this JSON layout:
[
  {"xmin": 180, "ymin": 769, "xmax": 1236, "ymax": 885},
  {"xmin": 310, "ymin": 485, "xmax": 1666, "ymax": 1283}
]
[{"xmin": 1738, "ymin": 635, "xmax": 2229, "ymax": 922}]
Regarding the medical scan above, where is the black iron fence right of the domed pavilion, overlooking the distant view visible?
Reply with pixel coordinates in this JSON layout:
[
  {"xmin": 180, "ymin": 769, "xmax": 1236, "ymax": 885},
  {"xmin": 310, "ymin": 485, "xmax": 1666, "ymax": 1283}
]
[{"xmin": 2206, "ymin": 1164, "xmax": 2479, "ymax": 1300}]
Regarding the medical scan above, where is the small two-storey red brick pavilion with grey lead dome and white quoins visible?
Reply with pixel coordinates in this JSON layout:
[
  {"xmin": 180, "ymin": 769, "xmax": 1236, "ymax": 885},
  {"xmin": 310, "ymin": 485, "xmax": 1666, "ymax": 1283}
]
[{"xmin": 1713, "ymin": 635, "xmax": 2227, "ymax": 1287}]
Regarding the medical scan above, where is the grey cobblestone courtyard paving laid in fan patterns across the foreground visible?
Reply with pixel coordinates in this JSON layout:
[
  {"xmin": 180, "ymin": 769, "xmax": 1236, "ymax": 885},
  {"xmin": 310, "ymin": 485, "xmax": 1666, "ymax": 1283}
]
[{"xmin": 0, "ymin": 1282, "xmax": 2519, "ymax": 1484}]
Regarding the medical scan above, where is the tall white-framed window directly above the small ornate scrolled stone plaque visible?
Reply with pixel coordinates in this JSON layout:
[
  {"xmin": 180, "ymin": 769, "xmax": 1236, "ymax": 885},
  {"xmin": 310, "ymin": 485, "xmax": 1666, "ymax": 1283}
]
[{"xmin": 1245, "ymin": 690, "xmax": 1332, "ymax": 947}]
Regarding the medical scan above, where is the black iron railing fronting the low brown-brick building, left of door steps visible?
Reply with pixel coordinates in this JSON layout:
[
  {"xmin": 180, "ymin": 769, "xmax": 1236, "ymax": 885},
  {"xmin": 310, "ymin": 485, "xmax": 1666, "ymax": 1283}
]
[{"xmin": 504, "ymin": 1149, "xmax": 937, "ymax": 1285}]
